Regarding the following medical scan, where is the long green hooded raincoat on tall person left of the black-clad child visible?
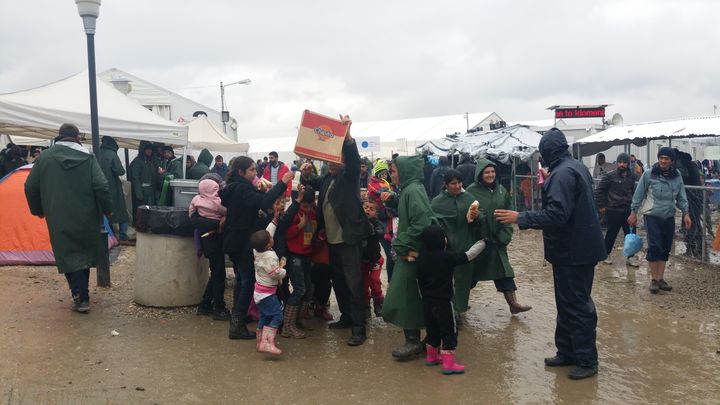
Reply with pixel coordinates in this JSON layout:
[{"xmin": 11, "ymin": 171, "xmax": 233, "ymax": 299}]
[{"xmin": 382, "ymin": 156, "xmax": 433, "ymax": 329}]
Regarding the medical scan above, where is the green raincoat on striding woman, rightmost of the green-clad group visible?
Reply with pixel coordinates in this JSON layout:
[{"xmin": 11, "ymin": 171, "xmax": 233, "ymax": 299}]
[{"xmin": 467, "ymin": 159, "xmax": 515, "ymax": 283}]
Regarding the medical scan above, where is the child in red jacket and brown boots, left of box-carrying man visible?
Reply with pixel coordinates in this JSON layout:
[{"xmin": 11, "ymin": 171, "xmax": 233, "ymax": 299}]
[{"xmin": 282, "ymin": 186, "xmax": 317, "ymax": 339}]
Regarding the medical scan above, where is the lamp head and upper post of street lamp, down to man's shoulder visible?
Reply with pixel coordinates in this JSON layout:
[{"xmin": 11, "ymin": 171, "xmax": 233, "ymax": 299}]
[{"xmin": 75, "ymin": 0, "xmax": 100, "ymax": 163}]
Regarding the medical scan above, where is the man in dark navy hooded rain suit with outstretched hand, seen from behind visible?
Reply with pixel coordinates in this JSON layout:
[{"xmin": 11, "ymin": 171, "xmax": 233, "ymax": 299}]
[{"xmin": 495, "ymin": 128, "xmax": 607, "ymax": 380}]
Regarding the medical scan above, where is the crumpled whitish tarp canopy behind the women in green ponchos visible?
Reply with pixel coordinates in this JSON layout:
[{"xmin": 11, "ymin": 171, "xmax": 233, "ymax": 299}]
[{"xmin": 416, "ymin": 125, "xmax": 542, "ymax": 164}]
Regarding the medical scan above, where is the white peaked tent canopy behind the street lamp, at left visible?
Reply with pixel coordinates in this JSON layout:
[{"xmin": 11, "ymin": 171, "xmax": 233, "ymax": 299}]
[{"xmin": 0, "ymin": 72, "xmax": 187, "ymax": 146}]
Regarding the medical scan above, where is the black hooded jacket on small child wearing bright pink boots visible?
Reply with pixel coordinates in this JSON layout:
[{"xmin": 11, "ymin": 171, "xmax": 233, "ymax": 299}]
[{"xmin": 417, "ymin": 225, "xmax": 468, "ymax": 301}]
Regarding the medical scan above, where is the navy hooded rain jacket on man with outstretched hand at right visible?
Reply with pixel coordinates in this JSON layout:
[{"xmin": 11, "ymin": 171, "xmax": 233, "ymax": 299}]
[{"xmin": 518, "ymin": 128, "xmax": 607, "ymax": 266}]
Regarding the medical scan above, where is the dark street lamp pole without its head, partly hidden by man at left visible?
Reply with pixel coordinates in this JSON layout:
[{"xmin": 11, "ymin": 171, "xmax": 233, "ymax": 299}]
[{"xmin": 85, "ymin": 32, "xmax": 111, "ymax": 287}]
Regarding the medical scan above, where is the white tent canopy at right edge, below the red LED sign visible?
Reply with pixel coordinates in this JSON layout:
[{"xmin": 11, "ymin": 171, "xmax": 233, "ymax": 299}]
[{"xmin": 573, "ymin": 115, "xmax": 720, "ymax": 156}]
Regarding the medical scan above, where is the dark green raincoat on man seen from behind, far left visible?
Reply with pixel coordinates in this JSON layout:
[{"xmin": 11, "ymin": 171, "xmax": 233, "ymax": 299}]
[{"xmin": 25, "ymin": 142, "xmax": 113, "ymax": 274}]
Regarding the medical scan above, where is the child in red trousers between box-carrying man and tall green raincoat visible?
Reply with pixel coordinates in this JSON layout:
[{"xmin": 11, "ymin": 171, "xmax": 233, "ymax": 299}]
[{"xmin": 360, "ymin": 200, "xmax": 385, "ymax": 317}]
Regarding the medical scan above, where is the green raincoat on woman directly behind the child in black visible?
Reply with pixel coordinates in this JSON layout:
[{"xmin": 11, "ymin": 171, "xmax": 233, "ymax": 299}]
[{"xmin": 431, "ymin": 190, "xmax": 480, "ymax": 313}]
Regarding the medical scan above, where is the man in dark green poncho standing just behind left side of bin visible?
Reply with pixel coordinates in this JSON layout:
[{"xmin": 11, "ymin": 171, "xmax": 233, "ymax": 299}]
[{"xmin": 129, "ymin": 141, "xmax": 160, "ymax": 224}]
